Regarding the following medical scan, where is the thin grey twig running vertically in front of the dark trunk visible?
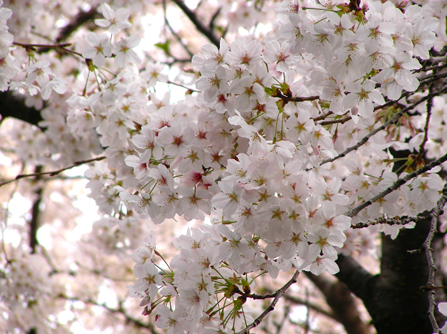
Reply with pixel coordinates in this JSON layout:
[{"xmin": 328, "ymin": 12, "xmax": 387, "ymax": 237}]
[{"xmin": 422, "ymin": 182, "xmax": 447, "ymax": 333}]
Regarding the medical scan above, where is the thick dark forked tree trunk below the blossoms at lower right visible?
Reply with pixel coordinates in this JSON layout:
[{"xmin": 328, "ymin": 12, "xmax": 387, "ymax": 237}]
[{"xmin": 336, "ymin": 222, "xmax": 432, "ymax": 334}]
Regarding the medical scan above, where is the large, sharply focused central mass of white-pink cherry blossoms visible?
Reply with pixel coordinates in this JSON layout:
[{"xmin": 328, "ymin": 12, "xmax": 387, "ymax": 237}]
[{"xmin": 113, "ymin": 1, "xmax": 442, "ymax": 332}]
